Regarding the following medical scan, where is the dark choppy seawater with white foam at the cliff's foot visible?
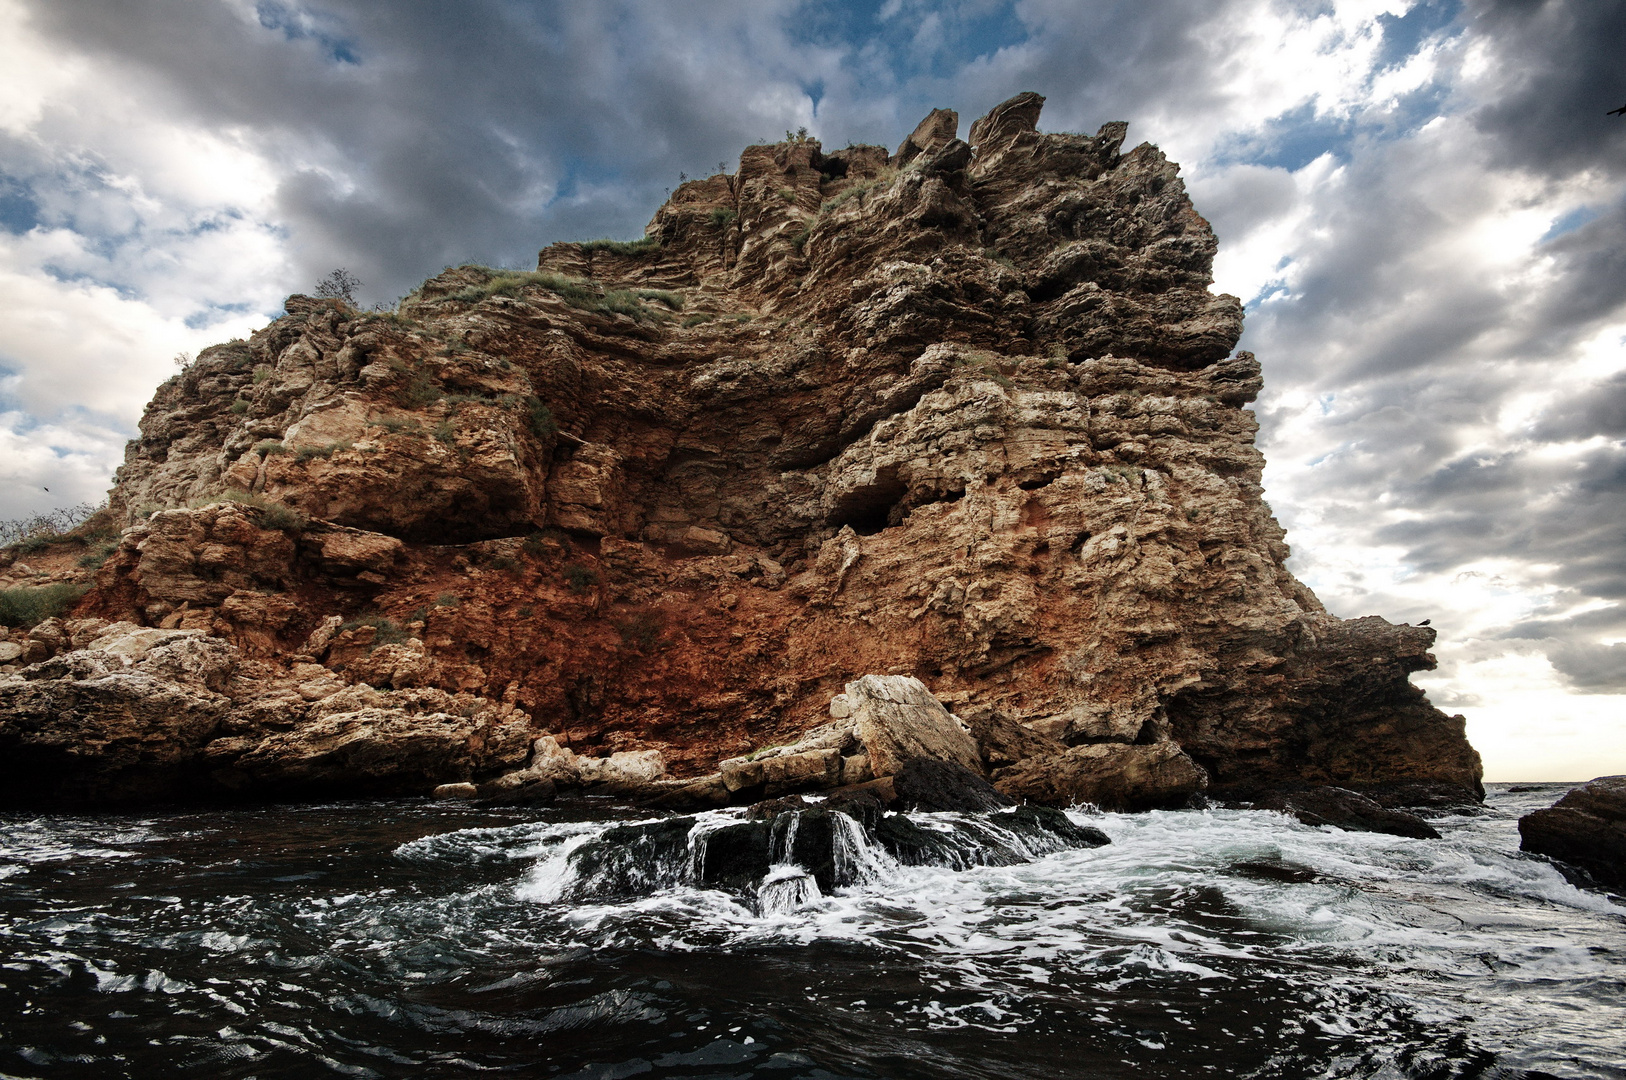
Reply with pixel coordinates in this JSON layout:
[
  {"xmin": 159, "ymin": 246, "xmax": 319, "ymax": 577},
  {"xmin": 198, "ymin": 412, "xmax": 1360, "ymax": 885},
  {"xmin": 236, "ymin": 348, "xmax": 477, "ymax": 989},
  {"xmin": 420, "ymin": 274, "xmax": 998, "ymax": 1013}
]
[{"xmin": 0, "ymin": 786, "xmax": 1626, "ymax": 1080}]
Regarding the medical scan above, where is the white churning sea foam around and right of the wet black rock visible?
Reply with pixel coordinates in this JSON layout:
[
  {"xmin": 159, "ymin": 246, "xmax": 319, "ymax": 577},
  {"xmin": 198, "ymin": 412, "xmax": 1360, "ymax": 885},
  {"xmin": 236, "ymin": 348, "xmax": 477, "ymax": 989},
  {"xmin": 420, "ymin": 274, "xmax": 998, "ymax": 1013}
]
[{"xmin": 491, "ymin": 793, "xmax": 1626, "ymax": 1073}]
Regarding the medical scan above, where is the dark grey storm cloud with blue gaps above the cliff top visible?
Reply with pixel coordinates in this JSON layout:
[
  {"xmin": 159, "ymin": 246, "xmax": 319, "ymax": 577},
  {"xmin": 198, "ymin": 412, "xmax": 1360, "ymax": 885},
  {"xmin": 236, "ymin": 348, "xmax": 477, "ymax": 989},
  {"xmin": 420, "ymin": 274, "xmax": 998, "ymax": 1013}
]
[{"xmin": 15, "ymin": 0, "xmax": 1281, "ymax": 307}]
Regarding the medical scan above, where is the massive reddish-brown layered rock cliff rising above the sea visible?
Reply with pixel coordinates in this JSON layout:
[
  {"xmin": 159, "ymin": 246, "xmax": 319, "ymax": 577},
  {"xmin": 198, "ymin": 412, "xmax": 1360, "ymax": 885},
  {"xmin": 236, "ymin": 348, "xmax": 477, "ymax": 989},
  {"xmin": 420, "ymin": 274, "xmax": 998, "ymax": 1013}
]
[{"xmin": 0, "ymin": 94, "xmax": 1480, "ymax": 803}]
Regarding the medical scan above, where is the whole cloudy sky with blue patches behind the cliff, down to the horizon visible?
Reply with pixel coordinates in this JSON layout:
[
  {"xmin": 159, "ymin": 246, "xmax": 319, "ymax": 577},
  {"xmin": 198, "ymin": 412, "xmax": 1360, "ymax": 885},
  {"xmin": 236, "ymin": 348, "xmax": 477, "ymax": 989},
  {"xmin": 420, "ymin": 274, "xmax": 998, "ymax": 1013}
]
[{"xmin": 0, "ymin": 0, "xmax": 1626, "ymax": 779}]
